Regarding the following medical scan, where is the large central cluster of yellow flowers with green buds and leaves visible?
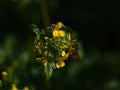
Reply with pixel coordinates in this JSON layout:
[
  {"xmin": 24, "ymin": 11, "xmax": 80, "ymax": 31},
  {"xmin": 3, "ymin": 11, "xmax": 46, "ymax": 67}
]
[{"xmin": 33, "ymin": 22, "xmax": 76, "ymax": 80}]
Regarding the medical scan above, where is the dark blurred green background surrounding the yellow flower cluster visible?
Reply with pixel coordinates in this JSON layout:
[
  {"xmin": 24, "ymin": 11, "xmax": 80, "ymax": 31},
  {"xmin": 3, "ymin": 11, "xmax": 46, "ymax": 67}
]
[{"xmin": 0, "ymin": 0, "xmax": 120, "ymax": 90}]
